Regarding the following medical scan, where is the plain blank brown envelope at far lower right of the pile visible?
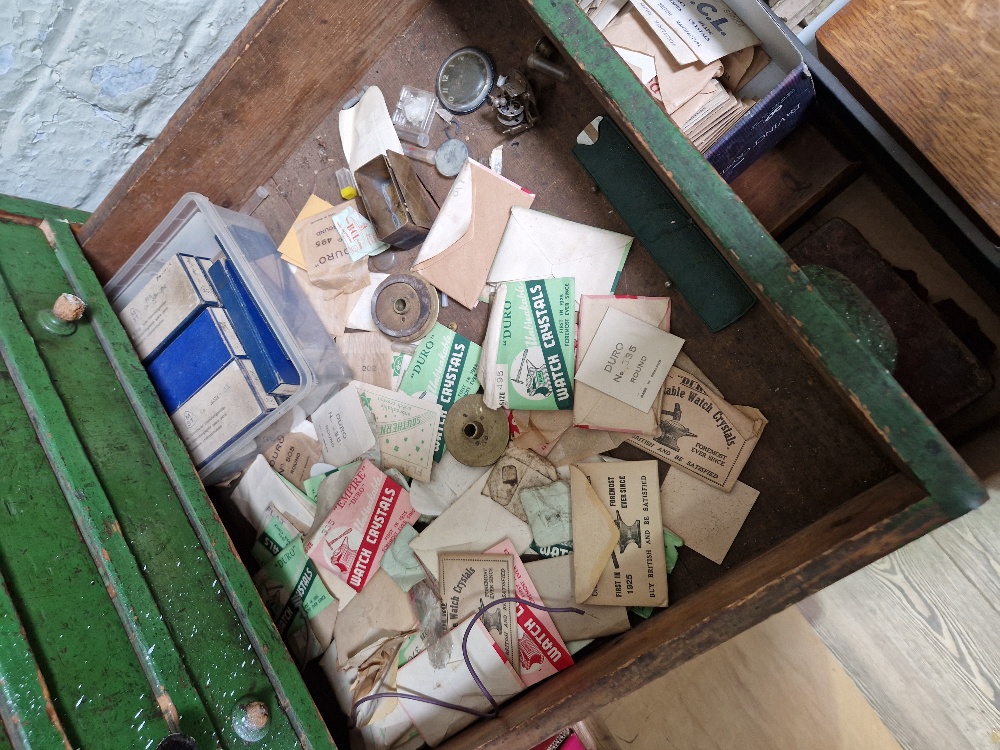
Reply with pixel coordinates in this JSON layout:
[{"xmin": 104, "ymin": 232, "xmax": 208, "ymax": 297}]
[{"xmin": 660, "ymin": 468, "xmax": 760, "ymax": 565}]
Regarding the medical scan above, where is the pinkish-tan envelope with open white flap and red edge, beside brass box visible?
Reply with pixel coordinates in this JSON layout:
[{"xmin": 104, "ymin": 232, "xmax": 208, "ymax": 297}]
[{"xmin": 413, "ymin": 159, "xmax": 535, "ymax": 309}]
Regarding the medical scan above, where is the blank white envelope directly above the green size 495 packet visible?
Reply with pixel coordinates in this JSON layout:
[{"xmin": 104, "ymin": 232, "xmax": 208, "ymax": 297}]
[{"xmin": 487, "ymin": 206, "xmax": 632, "ymax": 305}]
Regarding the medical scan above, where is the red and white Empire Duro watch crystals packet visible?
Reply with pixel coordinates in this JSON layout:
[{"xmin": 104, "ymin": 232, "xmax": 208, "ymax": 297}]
[{"xmin": 305, "ymin": 459, "xmax": 420, "ymax": 609}]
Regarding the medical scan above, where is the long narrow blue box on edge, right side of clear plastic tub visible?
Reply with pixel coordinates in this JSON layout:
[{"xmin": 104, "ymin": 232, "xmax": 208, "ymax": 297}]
[{"xmin": 208, "ymin": 257, "xmax": 301, "ymax": 396}]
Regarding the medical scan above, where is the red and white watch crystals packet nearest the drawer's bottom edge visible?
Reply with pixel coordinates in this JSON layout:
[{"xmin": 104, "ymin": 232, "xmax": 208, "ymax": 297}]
[{"xmin": 486, "ymin": 539, "xmax": 573, "ymax": 687}]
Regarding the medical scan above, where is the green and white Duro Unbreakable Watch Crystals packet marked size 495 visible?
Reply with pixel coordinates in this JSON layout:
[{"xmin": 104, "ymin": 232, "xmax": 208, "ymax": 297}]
[{"xmin": 479, "ymin": 278, "xmax": 576, "ymax": 411}]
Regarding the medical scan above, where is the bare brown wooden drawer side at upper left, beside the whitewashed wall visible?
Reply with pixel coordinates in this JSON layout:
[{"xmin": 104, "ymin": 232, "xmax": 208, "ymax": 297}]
[{"xmin": 79, "ymin": 0, "xmax": 434, "ymax": 281}]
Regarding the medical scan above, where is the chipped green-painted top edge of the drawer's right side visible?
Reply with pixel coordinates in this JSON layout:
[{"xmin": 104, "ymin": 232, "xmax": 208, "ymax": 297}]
[{"xmin": 526, "ymin": 0, "xmax": 986, "ymax": 517}]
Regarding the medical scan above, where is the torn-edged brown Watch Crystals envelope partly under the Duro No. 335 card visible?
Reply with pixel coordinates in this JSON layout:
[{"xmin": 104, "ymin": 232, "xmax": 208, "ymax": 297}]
[{"xmin": 629, "ymin": 367, "xmax": 767, "ymax": 494}]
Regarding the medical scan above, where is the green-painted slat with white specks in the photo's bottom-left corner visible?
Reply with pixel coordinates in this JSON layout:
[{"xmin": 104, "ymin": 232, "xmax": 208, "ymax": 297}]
[{"xmin": 0, "ymin": 577, "xmax": 70, "ymax": 750}]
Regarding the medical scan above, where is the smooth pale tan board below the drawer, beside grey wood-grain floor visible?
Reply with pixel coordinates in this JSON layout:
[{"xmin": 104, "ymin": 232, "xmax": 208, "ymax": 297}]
[{"xmin": 599, "ymin": 607, "xmax": 899, "ymax": 750}]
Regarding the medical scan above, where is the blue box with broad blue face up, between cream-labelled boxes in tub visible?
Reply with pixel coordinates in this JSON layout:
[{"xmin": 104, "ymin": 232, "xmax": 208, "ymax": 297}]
[{"xmin": 146, "ymin": 307, "xmax": 246, "ymax": 414}]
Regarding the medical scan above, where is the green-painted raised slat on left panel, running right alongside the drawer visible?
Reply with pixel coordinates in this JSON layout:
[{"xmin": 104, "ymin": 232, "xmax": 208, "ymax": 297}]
[{"xmin": 47, "ymin": 214, "xmax": 335, "ymax": 749}]
